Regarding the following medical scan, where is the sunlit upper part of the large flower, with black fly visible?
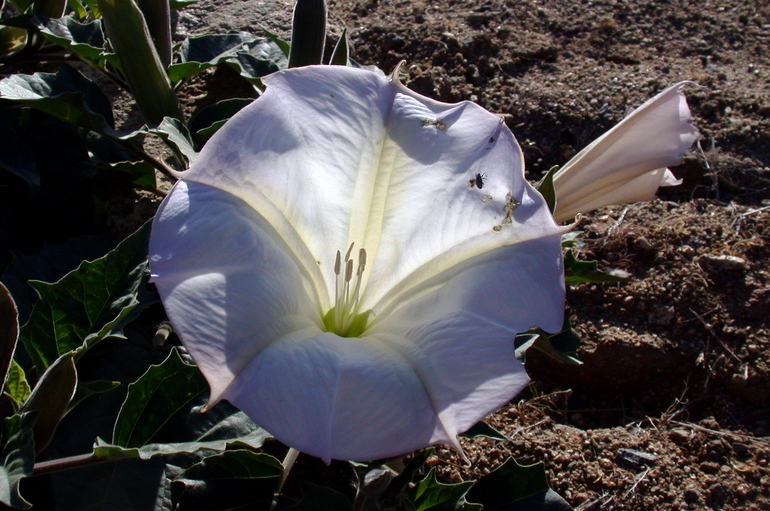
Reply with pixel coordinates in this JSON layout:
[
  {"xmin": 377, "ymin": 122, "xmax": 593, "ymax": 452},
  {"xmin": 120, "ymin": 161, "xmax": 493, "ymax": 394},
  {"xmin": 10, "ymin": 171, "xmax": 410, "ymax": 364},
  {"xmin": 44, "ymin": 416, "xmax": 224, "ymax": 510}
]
[{"xmin": 182, "ymin": 66, "xmax": 560, "ymax": 310}]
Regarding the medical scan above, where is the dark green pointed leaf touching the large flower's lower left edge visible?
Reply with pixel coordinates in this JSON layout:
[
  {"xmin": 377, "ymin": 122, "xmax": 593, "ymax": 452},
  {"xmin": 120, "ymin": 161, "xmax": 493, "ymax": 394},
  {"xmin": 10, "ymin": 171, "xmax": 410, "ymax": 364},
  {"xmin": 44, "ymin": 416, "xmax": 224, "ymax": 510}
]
[{"xmin": 112, "ymin": 348, "xmax": 208, "ymax": 447}]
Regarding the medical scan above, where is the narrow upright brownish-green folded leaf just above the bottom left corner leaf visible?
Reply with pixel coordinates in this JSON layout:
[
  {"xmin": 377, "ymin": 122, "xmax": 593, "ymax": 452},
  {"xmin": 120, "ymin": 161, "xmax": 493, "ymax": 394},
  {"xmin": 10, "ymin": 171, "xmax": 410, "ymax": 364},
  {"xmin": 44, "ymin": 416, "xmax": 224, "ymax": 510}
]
[{"xmin": 21, "ymin": 353, "xmax": 78, "ymax": 454}]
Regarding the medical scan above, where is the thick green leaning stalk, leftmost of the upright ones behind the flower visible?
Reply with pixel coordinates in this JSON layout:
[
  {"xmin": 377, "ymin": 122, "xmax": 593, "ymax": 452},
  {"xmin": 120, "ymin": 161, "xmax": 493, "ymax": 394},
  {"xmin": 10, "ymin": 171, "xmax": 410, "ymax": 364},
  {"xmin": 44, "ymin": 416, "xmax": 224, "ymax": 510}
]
[{"xmin": 96, "ymin": 0, "xmax": 184, "ymax": 125}]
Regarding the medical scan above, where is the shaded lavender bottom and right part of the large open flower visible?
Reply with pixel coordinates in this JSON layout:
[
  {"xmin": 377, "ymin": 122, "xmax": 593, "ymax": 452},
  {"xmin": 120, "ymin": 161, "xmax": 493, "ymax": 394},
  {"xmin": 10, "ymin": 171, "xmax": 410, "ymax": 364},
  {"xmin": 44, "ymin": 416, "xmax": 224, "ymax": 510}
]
[{"xmin": 219, "ymin": 236, "xmax": 564, "ymax": 462}]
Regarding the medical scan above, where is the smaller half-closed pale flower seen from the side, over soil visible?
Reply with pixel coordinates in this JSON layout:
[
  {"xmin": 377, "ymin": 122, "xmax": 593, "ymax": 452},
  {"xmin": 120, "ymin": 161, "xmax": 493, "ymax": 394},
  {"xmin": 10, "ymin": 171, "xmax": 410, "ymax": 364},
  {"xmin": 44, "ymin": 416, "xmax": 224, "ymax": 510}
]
[{"xmin": 553, "ymin": 82, "xmax": 700, "ymax": 222}]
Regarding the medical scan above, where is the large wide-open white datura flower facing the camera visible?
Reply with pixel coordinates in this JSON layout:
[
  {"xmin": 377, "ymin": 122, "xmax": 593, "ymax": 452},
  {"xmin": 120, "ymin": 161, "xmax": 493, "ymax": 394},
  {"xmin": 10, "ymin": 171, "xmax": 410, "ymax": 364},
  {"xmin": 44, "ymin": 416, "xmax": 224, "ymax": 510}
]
[{"xmin": 150, "ymin": 66, "xmax": 565, "ymax": 462}]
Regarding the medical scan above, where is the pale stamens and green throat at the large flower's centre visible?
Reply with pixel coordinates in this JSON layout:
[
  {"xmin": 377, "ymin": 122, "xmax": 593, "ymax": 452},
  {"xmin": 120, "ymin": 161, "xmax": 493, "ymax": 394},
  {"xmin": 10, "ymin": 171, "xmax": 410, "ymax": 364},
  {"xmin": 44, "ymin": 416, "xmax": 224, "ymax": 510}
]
[{"xmin": 323, "ymin": 243, "xmax": 372, "ymax": 337}]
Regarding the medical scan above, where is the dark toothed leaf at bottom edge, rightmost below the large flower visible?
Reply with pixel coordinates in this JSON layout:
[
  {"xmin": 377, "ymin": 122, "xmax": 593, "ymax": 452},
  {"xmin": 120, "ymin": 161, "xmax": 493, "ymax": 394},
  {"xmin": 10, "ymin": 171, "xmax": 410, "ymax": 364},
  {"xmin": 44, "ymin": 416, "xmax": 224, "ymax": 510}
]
[{"xmin": 468, "ymin": 458, "xmax": 572, "ymax": 511}]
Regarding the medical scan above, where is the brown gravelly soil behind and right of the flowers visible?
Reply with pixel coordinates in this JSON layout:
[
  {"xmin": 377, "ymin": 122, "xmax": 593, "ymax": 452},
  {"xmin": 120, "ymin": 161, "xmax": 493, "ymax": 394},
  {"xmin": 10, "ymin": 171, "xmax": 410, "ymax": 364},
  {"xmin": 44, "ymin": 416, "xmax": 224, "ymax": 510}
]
[{"xmin": 135, "ymin": 0, "xmax": 770, "ymax": 511}]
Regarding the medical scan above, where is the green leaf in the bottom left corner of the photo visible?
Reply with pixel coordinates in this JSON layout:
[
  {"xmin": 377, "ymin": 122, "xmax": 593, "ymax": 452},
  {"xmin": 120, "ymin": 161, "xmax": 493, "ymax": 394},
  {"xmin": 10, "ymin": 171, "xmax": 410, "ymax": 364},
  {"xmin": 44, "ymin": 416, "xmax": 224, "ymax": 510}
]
[{"xmin": 0, "ymin": 413, "xmax": 37, "ymax": 509}]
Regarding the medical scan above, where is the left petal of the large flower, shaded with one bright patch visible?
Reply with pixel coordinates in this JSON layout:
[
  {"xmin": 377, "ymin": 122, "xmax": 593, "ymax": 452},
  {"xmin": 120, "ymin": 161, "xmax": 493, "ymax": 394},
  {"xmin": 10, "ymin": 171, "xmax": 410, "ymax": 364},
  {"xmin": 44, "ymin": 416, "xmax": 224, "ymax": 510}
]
[{"xmin": 150, "ymin": 181, "xmax": 320, "ymax": 404}]
